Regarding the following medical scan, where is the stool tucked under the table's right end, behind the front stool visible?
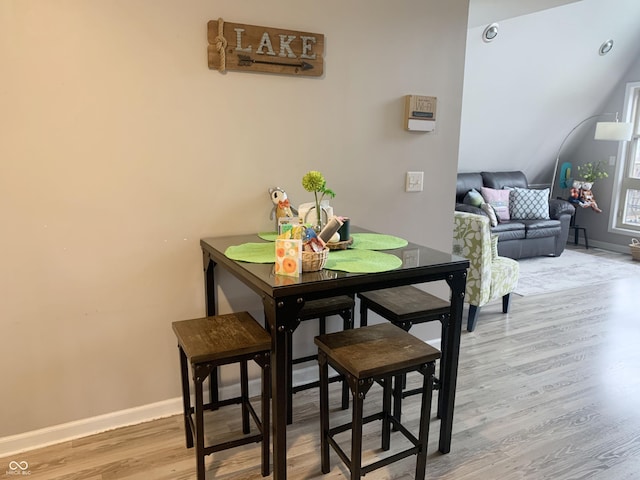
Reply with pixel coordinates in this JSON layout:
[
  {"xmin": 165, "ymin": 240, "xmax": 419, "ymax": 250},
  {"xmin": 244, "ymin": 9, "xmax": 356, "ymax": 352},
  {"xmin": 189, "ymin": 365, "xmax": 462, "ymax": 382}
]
[{"xmin": 358, "ymin": 285, "xmax": 450, "ymax": 421}]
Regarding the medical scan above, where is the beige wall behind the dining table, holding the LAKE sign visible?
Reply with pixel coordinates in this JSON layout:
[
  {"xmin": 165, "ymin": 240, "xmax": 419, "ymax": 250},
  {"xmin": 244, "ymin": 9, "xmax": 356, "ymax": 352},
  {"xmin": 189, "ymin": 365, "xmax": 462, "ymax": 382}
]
[{"xmin": 0, "ymin": 0, "xmax": 468, "ymax": 437}]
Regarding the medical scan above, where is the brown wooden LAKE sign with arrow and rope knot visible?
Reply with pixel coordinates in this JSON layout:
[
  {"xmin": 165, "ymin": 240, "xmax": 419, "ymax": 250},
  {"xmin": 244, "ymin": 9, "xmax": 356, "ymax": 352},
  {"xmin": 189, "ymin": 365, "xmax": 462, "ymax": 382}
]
[{"xmin": 207, "ymin": 18, "xmax": 324, "ymax": 77}]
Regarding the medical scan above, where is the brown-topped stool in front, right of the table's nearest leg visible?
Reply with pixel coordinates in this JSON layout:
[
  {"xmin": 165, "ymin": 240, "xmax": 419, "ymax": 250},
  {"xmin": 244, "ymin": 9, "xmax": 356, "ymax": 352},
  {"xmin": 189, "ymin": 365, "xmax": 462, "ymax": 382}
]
[{"xmin": 315, "ymin": 323, "xmax": 440, "ymax": 480}]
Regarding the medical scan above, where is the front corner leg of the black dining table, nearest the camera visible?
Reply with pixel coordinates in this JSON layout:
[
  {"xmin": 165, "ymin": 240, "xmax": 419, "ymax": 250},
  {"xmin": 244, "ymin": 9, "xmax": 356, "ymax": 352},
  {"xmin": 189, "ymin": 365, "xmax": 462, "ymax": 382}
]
[{"xmin": 262, "ymin": 296, "xmax": 304, "ymax": 480}]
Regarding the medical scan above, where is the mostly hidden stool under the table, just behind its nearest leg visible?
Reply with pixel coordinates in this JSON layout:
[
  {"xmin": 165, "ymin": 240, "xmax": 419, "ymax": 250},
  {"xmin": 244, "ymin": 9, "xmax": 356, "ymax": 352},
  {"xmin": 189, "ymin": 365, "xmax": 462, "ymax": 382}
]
[{"xmin": 287, "ymin": 295, "xmax": 355, "ymax": 424}]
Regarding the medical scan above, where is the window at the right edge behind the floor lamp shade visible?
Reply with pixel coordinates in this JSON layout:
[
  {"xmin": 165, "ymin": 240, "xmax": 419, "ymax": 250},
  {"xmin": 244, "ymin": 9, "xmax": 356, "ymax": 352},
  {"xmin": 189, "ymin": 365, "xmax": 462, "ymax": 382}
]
[{"xmin": 612, "ymin": 82, "xmax": 640, "ymax": 234}]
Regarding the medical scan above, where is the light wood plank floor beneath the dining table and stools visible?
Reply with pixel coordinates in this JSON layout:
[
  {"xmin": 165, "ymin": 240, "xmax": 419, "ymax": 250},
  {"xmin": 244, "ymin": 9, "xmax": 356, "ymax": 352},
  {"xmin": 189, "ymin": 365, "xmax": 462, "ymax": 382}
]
[{"xmin": 0, "ymin": 249, "xmax": 640, "ymax": 480}]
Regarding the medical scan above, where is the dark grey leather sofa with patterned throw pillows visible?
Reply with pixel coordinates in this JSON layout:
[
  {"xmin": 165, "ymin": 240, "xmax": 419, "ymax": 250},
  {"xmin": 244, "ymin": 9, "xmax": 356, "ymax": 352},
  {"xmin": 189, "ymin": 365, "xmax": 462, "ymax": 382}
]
[{"xmin": 456, "ymin": 171, "xmax": 575, "ymax": 259}]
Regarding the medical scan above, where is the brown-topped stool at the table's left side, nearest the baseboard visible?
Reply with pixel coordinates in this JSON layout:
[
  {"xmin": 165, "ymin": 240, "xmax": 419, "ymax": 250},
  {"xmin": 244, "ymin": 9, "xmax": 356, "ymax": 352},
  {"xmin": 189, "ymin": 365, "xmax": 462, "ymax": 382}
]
[{"xmin": 172, "ymin": 312, "xmax": 271, "ymax": 480}]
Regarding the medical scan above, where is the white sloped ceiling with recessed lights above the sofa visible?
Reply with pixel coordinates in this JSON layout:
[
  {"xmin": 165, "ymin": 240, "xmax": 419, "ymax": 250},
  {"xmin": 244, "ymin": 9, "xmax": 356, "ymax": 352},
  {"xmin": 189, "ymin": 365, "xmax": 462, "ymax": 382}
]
[{"xmin": 458, "ymin": 0, "xmax": 640, "ymax": 183}]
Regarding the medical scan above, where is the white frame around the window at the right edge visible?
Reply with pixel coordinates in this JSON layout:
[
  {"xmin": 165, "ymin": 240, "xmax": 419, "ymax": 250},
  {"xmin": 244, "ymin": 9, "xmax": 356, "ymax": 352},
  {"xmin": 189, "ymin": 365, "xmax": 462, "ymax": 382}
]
[{"xmin": 609, "ymin": 82, "xmax": 640, "ymax": 236}]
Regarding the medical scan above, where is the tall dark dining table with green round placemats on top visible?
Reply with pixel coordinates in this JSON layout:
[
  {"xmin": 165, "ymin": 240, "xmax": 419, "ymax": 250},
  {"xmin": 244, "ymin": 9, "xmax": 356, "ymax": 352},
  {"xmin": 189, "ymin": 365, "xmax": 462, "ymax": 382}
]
[{"xmin": 200, "ymin": 230, "xmax": 469, "ymax": 480}]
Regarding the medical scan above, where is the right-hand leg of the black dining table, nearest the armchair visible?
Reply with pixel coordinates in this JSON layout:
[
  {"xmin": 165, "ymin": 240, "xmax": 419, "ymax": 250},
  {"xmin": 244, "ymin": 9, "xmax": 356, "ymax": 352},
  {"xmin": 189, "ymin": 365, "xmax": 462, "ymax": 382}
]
[{"xmin": 438, "ymin": 272, "xmax": 467, "ymax": 453}]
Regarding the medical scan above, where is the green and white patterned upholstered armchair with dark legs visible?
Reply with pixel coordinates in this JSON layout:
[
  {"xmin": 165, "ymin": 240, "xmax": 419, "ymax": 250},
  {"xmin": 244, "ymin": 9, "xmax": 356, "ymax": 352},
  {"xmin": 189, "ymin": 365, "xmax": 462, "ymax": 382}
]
[{"xmin": 453, "ymin": 212, "xmax": 520, "ymax": 332}]
